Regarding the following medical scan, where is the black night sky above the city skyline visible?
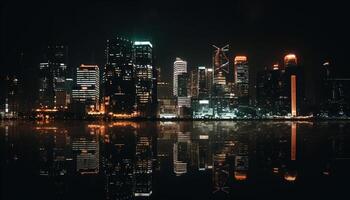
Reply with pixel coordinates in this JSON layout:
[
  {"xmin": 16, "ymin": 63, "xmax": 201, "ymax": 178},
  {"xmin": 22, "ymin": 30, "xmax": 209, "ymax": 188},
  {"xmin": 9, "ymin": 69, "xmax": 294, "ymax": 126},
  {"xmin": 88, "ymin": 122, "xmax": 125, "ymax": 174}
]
[{"xmin": 0, "ymin": 0, "xmax": 350, "ymax": 102}]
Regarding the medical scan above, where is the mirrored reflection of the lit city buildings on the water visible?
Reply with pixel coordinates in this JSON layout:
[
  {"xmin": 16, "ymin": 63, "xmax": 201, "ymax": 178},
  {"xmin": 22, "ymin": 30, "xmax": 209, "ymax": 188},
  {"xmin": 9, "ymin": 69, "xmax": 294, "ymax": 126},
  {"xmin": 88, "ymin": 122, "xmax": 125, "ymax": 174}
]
[{"xmin": 0, "ymin": 121, "xmax": 350, "ymax": 199}]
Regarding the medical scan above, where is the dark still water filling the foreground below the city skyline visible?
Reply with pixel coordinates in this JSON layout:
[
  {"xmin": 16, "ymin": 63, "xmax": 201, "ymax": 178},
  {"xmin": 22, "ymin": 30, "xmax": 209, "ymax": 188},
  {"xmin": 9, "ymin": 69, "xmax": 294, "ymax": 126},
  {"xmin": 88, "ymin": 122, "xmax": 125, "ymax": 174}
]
[{"xmin": 0, "ymin": 121, "xmax": 350, "ymax": 200}]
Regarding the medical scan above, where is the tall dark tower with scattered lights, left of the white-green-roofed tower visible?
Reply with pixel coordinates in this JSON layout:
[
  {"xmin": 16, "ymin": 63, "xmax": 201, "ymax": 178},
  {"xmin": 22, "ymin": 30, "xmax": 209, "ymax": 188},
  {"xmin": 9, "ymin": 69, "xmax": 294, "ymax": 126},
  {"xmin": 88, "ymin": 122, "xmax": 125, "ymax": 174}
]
[{"xmin": 103, "ymin": 37, "xmax": 136, "ymax": 114}]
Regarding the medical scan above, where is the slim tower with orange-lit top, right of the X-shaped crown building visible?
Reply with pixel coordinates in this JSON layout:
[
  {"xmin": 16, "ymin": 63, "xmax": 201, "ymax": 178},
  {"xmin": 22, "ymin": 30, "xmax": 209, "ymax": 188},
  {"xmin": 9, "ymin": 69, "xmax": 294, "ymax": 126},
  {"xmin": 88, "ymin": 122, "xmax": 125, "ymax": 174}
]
[{"xmin": 234, "ymin": 56, "xmax": 249, "ymax": 100}]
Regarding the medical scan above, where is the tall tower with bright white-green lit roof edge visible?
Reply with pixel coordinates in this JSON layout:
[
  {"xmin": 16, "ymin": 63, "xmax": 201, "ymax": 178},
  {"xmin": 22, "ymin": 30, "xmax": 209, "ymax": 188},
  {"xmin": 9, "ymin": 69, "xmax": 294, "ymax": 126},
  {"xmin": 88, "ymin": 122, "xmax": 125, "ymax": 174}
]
[{"xmin": 133, "ymin": 41, "xmax": 157, "ymax": 117}]
